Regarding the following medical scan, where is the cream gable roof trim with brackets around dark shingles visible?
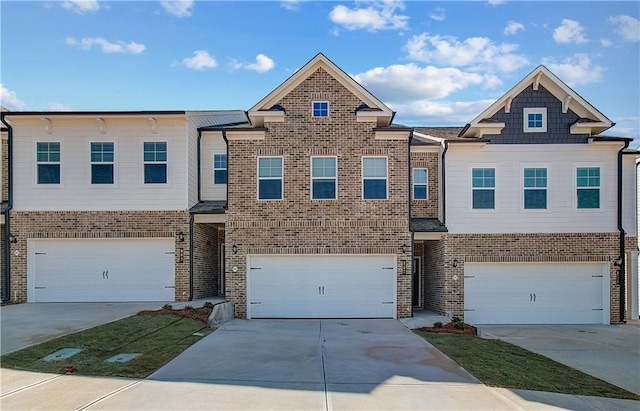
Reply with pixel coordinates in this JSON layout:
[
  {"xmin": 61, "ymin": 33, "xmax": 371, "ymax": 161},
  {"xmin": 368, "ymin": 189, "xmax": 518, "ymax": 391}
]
[{"xmin": 460, "ymin": 65, "xmax": 615, "ymax": 137}]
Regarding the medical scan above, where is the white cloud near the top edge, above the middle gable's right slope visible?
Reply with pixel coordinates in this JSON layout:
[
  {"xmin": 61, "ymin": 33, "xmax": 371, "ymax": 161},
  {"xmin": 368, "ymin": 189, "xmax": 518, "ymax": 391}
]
[{"xmin": 329, "ymin": 1, "xmax": 409, "ymax": 31}]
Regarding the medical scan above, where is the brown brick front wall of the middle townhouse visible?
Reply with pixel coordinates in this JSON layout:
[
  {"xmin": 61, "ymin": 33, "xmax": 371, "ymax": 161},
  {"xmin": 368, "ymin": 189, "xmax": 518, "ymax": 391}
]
[{"xmin": 225, "ymin": 68, "xmax": 411, "ymax": 318}]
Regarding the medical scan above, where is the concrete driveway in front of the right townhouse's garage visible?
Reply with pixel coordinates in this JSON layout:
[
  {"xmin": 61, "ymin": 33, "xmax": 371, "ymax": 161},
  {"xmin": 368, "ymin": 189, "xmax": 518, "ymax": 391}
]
[{"xmin": 479, "ymin": 324, "xmax": 640, "ymax": 395}]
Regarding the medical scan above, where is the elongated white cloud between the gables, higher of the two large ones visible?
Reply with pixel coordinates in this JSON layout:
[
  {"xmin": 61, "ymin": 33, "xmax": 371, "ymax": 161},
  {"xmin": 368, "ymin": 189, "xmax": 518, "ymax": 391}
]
[{"xmin": 405, "ymin": 33, "xmax": 529, "ymax": 73}]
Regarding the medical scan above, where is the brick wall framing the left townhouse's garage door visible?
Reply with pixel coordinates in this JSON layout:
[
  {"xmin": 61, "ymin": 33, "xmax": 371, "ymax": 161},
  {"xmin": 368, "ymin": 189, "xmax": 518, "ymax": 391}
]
[{"xmin": 10, "ymin": 211, "xmax": 191, "ymax": 302}]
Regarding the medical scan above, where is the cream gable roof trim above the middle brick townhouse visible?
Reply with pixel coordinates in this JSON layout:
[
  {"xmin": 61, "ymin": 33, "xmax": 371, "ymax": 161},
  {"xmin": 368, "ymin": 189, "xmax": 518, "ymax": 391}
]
[{"xmin": 248, "ymin": 53, "xmax": 395, "ymax": 127}]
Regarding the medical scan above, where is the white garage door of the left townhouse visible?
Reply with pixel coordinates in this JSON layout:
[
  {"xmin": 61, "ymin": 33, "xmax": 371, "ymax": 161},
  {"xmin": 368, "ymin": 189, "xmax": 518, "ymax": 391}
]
[{"xmin": 28, "ymin": 238, "xmax": 175, "ymax": 302}]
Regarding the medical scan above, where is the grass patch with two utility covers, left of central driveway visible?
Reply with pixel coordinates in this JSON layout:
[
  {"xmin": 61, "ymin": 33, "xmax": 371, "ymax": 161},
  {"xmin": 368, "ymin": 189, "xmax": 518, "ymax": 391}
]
[{"xmin": 0, "ymin": 315, "xmax": 213, "ymax": 378}]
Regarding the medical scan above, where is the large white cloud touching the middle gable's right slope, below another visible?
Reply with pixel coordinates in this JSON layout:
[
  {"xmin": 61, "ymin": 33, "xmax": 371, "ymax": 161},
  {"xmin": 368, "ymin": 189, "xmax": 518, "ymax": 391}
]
[{"xmin": 353, "ymin": 63, "xmax": 501, "ymax": 103}]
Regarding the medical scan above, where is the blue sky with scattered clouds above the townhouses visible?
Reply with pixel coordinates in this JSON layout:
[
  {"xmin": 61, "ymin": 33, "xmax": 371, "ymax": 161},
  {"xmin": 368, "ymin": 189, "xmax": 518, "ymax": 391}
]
[{"xmin": 0, "ymin": 0, "xmax": 640, "ymax": 145}]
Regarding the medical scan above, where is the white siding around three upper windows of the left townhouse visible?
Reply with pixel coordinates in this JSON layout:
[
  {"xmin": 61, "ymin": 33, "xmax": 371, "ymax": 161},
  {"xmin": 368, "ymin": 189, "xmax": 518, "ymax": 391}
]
[{"xmin": 14, "ymin": 116, "xmax": 187, "ymax": 211}]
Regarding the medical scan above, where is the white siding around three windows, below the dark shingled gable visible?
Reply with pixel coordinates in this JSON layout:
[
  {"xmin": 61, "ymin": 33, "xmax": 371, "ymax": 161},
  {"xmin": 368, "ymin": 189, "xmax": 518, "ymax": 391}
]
[{"xmin": 445, "ymin": 144, "xmax": 619, "ymax": 234}]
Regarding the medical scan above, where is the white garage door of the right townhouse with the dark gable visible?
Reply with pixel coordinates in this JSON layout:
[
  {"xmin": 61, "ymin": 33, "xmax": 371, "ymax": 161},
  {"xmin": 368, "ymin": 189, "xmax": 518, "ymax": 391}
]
[{"xmin": 464, "ymin": 263, "xmax": 609, "ymax": 324}]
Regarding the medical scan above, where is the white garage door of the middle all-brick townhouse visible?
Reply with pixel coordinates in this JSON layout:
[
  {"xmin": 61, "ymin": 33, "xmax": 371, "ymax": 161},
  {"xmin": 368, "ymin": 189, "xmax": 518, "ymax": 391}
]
[{"xmin": 247, "ymin": 255, "xmax": 396, "ymax": 318}]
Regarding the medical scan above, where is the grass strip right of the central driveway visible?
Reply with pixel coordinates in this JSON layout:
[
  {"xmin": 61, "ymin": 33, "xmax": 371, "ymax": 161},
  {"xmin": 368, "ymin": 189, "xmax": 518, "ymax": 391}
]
[{"xmin": 415, "ymin": 330, "xmax": 640, "ymax": 400}]
